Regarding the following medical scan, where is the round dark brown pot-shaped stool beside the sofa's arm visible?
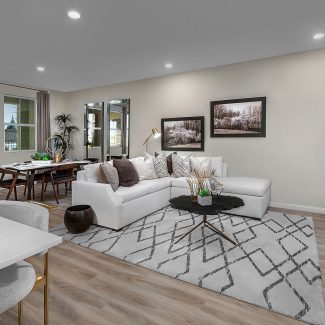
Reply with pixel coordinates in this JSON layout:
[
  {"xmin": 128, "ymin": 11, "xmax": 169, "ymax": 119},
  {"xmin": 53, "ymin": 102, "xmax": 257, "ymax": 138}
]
[{"xmin": 64, "ymin": 205, "xmax": 95, "ymax": 234}]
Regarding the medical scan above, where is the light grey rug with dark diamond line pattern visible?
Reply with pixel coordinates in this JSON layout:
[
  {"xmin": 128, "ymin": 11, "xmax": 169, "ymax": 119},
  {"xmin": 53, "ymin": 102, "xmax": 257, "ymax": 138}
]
[{"xmin": 51, "ymin": 206, "xmax": 325, "ymax": 324}]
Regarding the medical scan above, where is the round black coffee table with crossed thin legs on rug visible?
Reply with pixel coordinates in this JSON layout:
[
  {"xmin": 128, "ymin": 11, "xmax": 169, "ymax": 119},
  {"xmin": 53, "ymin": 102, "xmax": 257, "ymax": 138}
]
[{"xmin": 169, "ymin": 195, "xmax": 245, "ymax": 245}]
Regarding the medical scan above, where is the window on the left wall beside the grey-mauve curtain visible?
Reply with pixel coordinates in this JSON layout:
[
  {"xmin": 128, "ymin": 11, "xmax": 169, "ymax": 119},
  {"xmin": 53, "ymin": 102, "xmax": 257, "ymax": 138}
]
[{"xmin": 4, "ymin": 96, "xmax": 36, "ymax": 151}]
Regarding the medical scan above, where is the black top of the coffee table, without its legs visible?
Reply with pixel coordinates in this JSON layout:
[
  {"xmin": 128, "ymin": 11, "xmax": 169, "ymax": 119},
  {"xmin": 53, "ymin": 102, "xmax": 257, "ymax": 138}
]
[{"xmin": 169, "ymin": 195, "xmax": 245, "ymax": 215}]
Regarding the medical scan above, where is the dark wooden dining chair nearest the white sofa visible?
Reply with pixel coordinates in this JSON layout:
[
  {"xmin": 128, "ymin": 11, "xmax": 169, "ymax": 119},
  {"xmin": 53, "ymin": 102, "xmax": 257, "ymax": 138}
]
[{"xmin": 41, "ymin": 163, "xmax": 79, "ymax": 204}]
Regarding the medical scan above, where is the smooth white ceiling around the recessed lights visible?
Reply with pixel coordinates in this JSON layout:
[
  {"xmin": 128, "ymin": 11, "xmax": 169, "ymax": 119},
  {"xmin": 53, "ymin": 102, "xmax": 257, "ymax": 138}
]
[{"xmin": 0, "ymin": 0, "xmax": 325, "ymax": 91}]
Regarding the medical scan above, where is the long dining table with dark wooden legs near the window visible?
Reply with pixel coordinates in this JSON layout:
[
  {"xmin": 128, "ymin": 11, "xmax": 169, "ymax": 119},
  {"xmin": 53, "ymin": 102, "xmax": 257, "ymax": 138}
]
[{"xmin": 1, "ymin": 160, "xmax": 91, "ymax": 200}]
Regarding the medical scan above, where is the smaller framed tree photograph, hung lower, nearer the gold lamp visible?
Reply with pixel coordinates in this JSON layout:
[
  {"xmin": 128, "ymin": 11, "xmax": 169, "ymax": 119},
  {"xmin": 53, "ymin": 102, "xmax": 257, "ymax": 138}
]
[{"xmin": 161, "ymin": 116, "xmax": 204, "ymax": 151}]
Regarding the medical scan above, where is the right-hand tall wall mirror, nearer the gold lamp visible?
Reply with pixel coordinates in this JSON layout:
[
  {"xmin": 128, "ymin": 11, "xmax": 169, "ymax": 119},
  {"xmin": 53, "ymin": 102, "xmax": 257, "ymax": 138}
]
[{"xmin": 106, "ymin": 99, "xmax": 130, "ymax": 160}]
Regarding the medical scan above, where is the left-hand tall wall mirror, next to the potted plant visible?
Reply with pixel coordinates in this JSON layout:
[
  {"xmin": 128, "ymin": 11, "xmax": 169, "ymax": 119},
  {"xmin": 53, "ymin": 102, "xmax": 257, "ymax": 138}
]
[{"xmin": 84, "ymin": 102, "xmax": 104, "ymax": 161}]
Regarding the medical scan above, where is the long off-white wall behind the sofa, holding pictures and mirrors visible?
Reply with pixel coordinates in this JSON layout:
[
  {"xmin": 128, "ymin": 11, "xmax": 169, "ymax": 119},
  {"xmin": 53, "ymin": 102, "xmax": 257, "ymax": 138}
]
[{"xmin": 66, "ymin": 50, "xmax": 325, "ymax": 212}]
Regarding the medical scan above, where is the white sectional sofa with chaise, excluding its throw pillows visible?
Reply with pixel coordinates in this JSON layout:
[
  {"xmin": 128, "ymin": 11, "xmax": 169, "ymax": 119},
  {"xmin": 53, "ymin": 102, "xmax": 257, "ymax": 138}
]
[{"xmin": 72, "ymin": 157, "xmax": 271, "ymax": 230}]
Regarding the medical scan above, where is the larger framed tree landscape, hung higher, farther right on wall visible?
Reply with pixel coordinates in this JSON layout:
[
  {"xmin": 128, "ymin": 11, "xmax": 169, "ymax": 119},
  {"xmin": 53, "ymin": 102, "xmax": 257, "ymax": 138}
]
[{"xmin": 210, "ymin": 97, "xmax": 266, "ymax": 137}]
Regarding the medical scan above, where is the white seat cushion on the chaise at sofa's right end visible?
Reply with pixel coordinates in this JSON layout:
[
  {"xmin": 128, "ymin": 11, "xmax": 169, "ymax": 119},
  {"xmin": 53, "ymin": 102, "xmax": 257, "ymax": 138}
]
[{"xmin": 218, "ymin": 177, "xmax": 271, "ymax": 196}]
